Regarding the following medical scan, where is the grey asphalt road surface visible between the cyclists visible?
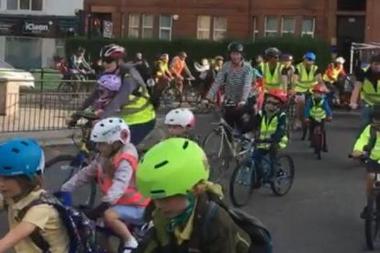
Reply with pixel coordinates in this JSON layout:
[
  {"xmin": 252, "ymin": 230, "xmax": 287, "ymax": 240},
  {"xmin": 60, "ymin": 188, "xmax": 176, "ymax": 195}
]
[{"xmin": 0, "ymin": 113, "xmax": 372, "ymax": 253}]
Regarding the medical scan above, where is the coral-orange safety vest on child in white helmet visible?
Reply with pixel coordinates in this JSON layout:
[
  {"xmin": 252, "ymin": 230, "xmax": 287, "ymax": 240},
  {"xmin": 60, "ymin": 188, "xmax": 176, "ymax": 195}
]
[{"xmin": 97, "ymin": 152, "xmax": 150, "ymax": 207}]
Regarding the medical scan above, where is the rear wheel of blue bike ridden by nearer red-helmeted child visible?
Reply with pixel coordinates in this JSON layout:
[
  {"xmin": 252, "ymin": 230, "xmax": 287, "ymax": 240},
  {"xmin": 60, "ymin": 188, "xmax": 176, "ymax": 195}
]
[{"xmin": 270, "ymin": 155, "xmax": 295, "ymax": 196}]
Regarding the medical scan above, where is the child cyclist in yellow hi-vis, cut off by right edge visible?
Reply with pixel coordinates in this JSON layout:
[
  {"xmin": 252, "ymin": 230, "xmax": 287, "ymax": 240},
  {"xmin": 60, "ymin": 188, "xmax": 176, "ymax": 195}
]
[{"xmin": 352, "ymin": 105, "xmax": 380, "ymax": 219}]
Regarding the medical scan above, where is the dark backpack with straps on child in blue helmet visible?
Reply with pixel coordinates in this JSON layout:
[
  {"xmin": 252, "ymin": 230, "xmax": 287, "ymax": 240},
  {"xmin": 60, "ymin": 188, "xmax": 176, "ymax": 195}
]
[{"xmin": 16, "ymin": 193, "xmax": 97, "ymax": 253}]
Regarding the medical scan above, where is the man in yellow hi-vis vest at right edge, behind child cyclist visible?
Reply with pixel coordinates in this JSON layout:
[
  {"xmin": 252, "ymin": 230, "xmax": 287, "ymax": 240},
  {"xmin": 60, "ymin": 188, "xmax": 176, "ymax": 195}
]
[{"xmin": 350, "ymin": 54, "xmax": 380, "ymax": 130}]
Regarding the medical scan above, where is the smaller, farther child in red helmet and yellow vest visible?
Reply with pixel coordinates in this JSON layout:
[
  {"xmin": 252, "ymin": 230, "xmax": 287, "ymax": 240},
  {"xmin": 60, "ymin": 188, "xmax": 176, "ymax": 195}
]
[{"xmin": 304, "ymin": 84, "xmax": 332, "ymax": 152}]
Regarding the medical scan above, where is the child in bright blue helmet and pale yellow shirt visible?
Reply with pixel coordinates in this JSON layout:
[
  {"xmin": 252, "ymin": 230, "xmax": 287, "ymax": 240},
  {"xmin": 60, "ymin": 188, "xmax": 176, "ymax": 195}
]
[{"xmin": 0, "ymin": 138, "xmax": 70, "ymax": 253}]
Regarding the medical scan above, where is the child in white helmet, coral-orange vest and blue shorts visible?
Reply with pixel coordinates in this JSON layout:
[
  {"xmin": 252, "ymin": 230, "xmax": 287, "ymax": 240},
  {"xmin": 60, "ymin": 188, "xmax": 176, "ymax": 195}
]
[{"xmin": 61, "ymin": 118, "xmax": 149, "ymax": 253}]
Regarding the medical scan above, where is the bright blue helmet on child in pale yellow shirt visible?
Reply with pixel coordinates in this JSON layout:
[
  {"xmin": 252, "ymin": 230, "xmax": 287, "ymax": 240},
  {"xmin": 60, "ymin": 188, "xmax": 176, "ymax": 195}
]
[{"xmin": 0, "ymin": 138, "xmax": 45, "ymax": 177}]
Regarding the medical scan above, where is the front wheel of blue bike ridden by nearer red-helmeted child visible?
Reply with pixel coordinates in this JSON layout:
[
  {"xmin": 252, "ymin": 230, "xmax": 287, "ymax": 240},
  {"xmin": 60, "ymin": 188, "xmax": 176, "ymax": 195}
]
[{"xmin": 230, "ymin": 160, "xmax": 257, "ymax": 207}]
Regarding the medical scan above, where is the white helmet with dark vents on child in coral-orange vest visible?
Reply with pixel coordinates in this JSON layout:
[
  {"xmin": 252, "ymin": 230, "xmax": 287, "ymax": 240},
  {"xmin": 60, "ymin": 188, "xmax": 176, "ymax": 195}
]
[{"xmin": 91, "ymin": 117, "xmax": 131, "ymax": 144}]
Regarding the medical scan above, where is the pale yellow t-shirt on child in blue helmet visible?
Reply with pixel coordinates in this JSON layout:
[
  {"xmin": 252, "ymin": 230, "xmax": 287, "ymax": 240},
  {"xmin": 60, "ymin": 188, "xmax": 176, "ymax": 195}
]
[{"xmin": 0, "ymin": 190, "xmax": 69, "ymax": 253}]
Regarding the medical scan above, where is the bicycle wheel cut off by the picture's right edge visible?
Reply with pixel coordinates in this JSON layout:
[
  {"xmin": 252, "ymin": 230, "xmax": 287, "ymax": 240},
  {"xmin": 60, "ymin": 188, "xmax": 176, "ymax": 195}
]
[{"xmin": 364, "ymin": 195, "xmax": 380, "ymax": 250}]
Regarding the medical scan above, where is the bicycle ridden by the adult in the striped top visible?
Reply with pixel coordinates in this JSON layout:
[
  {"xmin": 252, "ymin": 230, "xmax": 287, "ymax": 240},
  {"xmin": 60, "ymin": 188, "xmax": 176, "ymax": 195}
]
[{"xmin": 202, "ymin": 105, "xmax": 250, "ymax": 182}]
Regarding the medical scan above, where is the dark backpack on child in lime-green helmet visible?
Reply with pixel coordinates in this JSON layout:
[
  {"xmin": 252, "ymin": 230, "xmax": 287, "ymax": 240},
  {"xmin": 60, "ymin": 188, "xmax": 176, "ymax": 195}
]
[{"xmin": 201, "ymin": 194, "xmax": 272, "ymax": 253}]
